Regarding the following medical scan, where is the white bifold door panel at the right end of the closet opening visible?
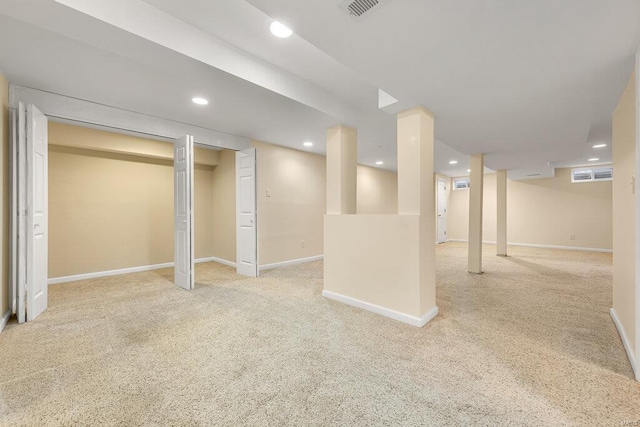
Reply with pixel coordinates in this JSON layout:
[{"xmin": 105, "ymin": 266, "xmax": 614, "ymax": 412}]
[{"xmin": 236, "ymin": 148, "xmax": 258, "ymax": 277}]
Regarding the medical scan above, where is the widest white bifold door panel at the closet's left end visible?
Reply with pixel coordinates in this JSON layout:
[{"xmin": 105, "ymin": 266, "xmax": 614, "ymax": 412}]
[{"xmin": 25, "ymin": 105, "xmax": 49, "ymax": 321}]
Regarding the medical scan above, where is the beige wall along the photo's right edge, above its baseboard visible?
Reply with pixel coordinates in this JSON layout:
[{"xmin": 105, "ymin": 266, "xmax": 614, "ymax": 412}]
[{"xmin": 612, "ymin": 73, "xmax": 637, "ymax": 351}]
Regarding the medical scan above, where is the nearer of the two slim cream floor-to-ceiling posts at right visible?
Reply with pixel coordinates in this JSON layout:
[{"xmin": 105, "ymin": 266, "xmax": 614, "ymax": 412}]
[{"xmin": 468, "ymin": 154, "xmax": 484, "ymax": 274}]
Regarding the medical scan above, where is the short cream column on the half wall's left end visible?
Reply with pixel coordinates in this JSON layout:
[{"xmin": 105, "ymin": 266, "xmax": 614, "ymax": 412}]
[{"xmin": 327, "ymin": 126, "xmax": 358, "ymax": 215}]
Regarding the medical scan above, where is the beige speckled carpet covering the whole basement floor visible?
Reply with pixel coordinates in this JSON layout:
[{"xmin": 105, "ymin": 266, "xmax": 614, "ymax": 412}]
[{"xmin": 0, "ymin": 243, "xmax": 640, "ymax": 426}]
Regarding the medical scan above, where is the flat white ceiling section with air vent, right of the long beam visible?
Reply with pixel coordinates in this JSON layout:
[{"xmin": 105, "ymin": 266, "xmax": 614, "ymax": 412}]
[{"xmin": 248, "ymin": 0, "xmax": 640, "ymax": 169}]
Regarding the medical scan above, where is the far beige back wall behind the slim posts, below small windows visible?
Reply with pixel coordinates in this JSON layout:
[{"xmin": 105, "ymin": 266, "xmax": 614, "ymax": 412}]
[{"xmin": 448, "ymin": 168, "xmax": 617, "ymax": 249}]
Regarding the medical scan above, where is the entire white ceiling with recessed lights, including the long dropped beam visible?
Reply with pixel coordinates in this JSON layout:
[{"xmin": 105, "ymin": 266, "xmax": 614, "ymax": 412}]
[{"xmin": 0, "ymin": 0, "xmax": 640, "ymax": 176}]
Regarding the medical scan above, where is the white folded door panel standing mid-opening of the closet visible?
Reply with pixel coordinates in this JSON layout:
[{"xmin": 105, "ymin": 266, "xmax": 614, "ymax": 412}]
[{"xmin": 173, "ymin": 135, "xmax": 195, "ymax": 289}]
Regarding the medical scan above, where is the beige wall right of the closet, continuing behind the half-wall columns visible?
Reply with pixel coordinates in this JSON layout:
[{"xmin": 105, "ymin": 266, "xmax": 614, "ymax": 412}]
[{"xmin": 250, "ymin": 141, "xmax": 398, "ymax": 265}]
